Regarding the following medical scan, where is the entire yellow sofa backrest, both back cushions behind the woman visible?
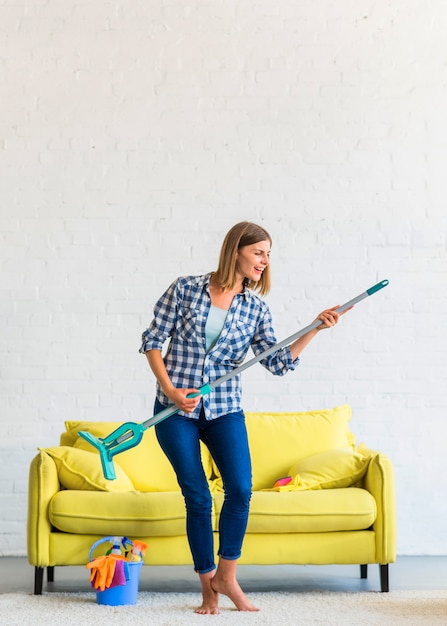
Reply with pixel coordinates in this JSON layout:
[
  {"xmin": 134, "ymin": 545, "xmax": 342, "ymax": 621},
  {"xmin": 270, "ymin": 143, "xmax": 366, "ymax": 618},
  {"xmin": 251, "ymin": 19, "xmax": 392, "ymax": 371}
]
[{"xmin": 60, "ymin": 404, "xmax": 355, "ymax": 492}]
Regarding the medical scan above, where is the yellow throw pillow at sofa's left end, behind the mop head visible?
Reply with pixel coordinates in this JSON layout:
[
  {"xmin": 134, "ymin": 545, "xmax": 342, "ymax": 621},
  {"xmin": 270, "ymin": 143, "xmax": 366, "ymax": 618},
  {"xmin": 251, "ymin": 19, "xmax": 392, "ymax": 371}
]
[{"xmin": 39, "ymin": 446, "xmax": 135, "ymax": 491}]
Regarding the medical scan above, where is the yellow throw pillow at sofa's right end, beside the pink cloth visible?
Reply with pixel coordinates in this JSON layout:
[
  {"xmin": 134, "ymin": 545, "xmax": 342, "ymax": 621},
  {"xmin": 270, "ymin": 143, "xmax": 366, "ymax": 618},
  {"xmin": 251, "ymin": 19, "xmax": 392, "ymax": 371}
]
[{"xmin": 282, "ymin": 448, "xmax": 371, "ymax": 491}]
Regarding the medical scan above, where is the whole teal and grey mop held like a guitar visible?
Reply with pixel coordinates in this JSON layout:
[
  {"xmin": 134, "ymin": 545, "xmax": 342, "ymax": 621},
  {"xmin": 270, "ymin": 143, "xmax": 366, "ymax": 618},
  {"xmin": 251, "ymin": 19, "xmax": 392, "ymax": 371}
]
[{"xmin": 79, "ymin": 280, "xmax": 389, "ymax": 480}]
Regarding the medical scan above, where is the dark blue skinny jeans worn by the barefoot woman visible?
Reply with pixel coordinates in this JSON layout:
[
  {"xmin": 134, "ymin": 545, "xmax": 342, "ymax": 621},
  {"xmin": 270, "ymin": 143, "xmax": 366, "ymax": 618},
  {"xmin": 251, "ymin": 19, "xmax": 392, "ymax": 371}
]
[{"xmin": 155, "ymin": 400, "xmax": 251, "ymax": 574}]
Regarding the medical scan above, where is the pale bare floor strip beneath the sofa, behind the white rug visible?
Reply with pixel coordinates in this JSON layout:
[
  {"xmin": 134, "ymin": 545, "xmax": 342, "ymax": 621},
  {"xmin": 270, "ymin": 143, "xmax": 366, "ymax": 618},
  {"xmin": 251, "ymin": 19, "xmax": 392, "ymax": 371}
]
[{"xmin": 0, "ymin": 556, "xmax": 447, "ymax": 593}]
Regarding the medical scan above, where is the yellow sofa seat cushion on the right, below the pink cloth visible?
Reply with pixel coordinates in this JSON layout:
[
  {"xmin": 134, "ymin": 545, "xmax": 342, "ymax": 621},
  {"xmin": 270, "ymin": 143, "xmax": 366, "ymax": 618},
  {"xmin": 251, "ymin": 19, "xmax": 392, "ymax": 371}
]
[{"xmin": 214, "ymin": 487, "xmax": 377, "ymax": 541}]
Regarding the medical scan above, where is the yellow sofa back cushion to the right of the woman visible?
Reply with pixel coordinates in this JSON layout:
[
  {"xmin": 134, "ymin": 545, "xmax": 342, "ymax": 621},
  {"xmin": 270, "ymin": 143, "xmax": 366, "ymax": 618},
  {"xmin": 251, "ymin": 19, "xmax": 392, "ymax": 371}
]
[{"xmin": 213, "ymin": 404, "xmax": 355, "ymax": 491}]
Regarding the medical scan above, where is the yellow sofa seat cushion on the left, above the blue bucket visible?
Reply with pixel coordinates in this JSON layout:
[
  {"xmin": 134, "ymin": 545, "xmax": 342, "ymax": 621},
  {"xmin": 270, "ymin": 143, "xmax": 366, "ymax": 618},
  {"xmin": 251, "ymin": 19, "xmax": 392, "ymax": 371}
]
[{"xmin": 49, "ymin": 491, "xmax": 195, "ymax": 537}]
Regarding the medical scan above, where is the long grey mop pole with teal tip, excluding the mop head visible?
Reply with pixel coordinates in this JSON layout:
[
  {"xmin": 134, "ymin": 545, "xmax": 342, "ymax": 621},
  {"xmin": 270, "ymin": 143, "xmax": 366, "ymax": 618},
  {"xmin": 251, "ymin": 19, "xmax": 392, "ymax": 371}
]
[{"xmin": 140, "ymin": 280, "xmax": 389, "ymax": 428}]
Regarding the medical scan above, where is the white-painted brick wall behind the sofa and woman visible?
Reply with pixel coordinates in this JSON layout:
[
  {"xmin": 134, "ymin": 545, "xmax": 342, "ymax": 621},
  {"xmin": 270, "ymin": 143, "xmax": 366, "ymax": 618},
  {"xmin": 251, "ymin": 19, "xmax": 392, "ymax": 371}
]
[{"xmin": 0, "ymin": 0, "xmax": 447, "ymax": 555}]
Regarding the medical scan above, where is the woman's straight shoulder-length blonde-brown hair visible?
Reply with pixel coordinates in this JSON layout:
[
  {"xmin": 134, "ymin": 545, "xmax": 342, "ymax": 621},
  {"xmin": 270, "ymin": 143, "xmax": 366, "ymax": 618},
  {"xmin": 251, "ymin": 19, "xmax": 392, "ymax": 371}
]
[{"xmin": 215, "ymin": 222, "xmax": 272, "ymax": 296}]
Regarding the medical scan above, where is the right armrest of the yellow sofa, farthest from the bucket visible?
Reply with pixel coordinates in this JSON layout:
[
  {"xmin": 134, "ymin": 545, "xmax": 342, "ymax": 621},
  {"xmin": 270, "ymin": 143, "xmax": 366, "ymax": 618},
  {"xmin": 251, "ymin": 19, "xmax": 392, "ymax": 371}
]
[{"xmin": 363, "ymin": 450, "xmax": 396, "ymax": 564}]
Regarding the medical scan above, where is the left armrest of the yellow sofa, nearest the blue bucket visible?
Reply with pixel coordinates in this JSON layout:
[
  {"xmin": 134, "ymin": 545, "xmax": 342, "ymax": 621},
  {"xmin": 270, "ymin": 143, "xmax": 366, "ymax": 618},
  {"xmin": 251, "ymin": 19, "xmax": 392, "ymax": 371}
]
[{"xmin": 26, "ymin": 451, "xmax": 61, "ymax": 567}]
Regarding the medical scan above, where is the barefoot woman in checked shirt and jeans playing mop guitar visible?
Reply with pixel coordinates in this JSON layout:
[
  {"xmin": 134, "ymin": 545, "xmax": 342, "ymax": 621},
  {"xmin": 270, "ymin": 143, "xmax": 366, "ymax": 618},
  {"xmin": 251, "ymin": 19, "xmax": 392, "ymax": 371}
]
[{"xmin": 140, "ymin": 222, "xmax": 346, "ymax": 614}]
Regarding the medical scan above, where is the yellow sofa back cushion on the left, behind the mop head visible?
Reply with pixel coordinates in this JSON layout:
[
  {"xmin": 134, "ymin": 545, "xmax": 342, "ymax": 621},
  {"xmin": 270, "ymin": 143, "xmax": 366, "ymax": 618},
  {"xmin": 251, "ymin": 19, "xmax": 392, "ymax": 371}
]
[{"xmin": 61, "ymin": 421, "xmax": 212, "ymax": 492}]
